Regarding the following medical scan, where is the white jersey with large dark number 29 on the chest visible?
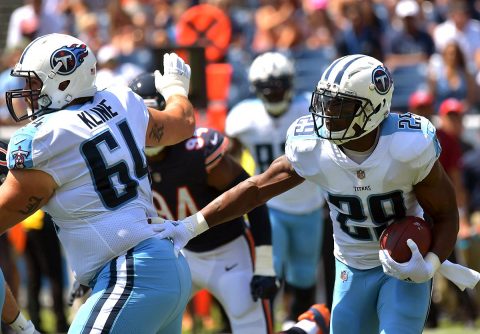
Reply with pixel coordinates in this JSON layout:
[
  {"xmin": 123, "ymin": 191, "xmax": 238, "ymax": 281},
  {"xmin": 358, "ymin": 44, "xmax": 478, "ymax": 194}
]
[{"xmin": 285, "ymin": 114, "xmax": 441, "ymax": 269}]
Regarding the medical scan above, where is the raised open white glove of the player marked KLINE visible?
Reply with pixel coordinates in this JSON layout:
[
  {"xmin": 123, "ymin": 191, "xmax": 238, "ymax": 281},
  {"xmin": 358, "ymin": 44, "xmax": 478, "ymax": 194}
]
[{"xmin": 154, "ymin": 53, "xmax": 191, "ymax": 101}]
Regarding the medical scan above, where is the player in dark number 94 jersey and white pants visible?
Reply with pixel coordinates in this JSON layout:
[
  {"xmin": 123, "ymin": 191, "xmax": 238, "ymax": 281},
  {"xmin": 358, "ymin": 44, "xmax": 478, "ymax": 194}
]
[{"xmin": 130, "ymin": 73, "xmax": 278, "ymax": 334}]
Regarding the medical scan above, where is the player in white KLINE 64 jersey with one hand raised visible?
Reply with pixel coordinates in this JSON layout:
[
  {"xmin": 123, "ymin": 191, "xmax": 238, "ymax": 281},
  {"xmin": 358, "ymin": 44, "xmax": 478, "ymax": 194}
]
[{"xmin": 0, "ymin": 34, "xmax": 195, "ymax": 333}]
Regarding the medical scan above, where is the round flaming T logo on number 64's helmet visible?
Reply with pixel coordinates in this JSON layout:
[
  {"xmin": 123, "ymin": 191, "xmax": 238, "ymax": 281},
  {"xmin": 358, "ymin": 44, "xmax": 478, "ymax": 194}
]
[{"xmin": 50, "ymin": 44, "xmax": 88, "ymax": 75}]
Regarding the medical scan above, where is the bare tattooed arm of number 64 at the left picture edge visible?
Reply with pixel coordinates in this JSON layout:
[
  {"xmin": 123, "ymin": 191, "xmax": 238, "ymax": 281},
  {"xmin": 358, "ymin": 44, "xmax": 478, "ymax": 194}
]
[{"xmin": 0, "ymin": 169, "xmax": 57, "ymax": 234}]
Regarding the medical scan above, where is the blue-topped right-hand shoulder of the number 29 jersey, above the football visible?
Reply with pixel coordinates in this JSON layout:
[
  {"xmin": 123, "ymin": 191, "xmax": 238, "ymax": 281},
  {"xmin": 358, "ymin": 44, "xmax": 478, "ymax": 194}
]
[{"xmin": 382, "ymin": 113, "xmax": 441, "ymax": 166}]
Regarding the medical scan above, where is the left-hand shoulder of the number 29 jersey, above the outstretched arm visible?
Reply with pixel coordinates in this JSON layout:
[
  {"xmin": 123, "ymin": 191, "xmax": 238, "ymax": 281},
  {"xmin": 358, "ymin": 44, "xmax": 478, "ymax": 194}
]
[{"xmin": 285, "ymin": 115, "xmax": 320, "ymax": 177}]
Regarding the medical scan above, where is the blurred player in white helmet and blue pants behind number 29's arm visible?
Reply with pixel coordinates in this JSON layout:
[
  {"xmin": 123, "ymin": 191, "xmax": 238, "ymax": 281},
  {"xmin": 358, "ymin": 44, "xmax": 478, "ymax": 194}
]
[{"xmin": 225, "ymin": 52, "xmax": 324, "ymax": 328}]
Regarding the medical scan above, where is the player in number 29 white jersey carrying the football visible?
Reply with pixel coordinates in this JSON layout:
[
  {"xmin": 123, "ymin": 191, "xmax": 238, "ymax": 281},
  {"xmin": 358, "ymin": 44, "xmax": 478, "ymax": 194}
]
[{"xmin": 152, "ymin": 54, "xmax": 458, "ymax": 334}]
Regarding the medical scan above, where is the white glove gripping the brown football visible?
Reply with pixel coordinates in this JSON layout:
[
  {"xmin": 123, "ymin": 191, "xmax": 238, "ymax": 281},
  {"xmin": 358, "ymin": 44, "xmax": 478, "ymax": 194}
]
[{"xmin": 379, "ymin": 239, "xmax": 440, "ymax": 283}]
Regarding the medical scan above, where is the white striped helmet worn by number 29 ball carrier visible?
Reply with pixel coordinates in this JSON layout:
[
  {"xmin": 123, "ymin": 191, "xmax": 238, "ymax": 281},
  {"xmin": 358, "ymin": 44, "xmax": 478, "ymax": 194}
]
[{"xmin": 310, "ymin": 54, "xmax": 393, "ymax": 145}]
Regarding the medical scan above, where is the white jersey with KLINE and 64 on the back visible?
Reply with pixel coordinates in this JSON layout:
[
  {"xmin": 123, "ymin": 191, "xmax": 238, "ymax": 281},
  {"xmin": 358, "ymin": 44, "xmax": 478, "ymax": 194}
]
[{"xmin": 8, "ymin": 87, "xmax": 156, "ymax": 284}]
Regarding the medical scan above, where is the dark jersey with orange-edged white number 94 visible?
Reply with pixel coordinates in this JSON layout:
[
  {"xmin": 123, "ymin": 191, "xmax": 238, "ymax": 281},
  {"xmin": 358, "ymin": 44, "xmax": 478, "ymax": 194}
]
[{"xmin": 149, "ymin": 128, "xmax": 245, "ymax": 252}]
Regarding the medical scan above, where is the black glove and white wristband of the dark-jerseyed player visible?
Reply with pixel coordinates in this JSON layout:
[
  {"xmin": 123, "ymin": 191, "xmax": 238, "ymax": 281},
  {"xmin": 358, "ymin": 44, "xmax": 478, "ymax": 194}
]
[{"xmin": 250, "ymin": 245, "xmax": 280, "ymax": 302}]
